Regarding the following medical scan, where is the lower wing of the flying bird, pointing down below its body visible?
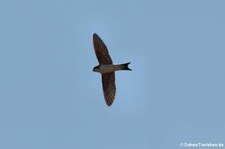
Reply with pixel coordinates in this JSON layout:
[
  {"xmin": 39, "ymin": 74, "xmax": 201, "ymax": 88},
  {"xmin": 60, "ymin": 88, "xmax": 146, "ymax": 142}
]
[{"xmin": 102, "ymin": 72, "xmax": 116, "ymax": 106}]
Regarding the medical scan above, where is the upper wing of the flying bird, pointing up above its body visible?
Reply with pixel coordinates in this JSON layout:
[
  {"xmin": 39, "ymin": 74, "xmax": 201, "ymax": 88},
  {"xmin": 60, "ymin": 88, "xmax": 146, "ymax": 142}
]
[{"xmin": 93, "ymin": 33, "xmax": 113, "ymax": 64}]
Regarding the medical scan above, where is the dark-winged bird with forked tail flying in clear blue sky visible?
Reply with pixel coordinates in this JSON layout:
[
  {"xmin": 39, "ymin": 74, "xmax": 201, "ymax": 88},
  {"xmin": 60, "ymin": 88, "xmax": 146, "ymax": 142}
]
[{"xmin": 93, "ymin": 33, "xmax": 131, "ymax": 106}]
